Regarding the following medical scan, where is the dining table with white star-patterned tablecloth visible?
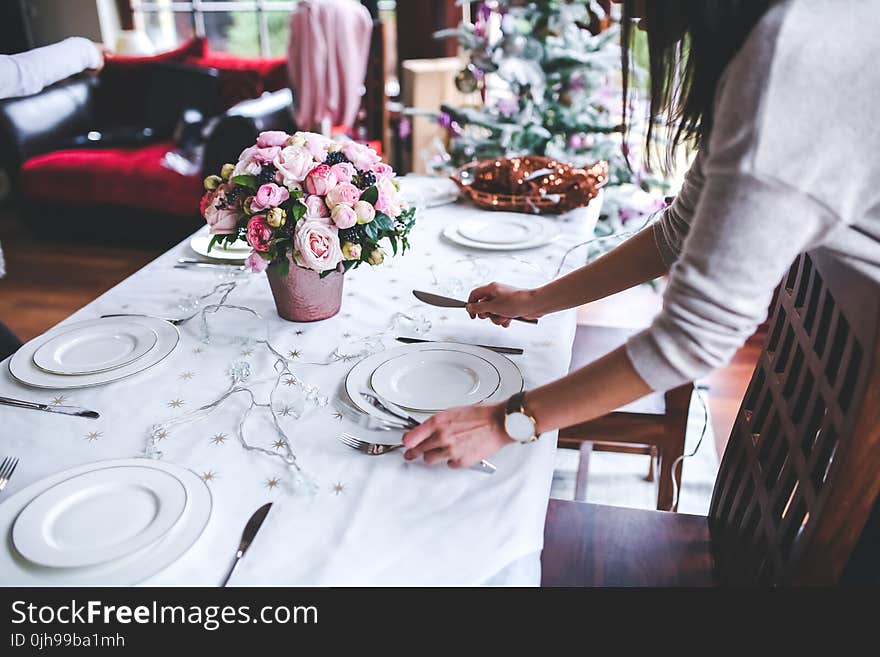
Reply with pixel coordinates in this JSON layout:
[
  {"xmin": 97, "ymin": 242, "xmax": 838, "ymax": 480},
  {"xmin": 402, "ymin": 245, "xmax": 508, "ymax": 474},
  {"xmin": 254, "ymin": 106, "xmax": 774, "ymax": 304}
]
[{"xmin": 0, "ymin": 178, "xmax": 593, "ymax": 586}]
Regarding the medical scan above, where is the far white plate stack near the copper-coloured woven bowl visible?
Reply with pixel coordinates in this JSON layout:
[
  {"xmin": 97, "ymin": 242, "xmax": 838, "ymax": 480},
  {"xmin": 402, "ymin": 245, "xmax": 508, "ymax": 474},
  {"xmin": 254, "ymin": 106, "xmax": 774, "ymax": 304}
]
[{"xmin": 443, "ymin": 212, "xmax": 559, "ymax": 251}]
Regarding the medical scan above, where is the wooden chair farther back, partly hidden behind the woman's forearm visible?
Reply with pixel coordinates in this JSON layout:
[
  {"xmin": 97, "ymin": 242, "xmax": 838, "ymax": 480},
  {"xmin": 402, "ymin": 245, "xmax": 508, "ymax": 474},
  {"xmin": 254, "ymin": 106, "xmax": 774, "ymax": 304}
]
[{"xmin": 557, "ymin": 326, "xmax": 694, "ymax": 511}]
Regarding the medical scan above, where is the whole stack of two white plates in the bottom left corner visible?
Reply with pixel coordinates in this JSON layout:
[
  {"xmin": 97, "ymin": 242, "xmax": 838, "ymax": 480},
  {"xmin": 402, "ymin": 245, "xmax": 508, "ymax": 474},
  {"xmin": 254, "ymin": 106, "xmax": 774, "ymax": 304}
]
[{"xmin": 0, "ymin": 458, "xmax": 211, "ymax": 586}]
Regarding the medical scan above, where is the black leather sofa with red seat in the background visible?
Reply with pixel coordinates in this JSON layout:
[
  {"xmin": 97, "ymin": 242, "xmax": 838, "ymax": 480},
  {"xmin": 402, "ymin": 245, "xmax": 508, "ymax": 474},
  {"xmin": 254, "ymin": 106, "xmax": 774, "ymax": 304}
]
[{"xmin": 0, "ymin": 39, "xmax": 293, "ymax": 249}]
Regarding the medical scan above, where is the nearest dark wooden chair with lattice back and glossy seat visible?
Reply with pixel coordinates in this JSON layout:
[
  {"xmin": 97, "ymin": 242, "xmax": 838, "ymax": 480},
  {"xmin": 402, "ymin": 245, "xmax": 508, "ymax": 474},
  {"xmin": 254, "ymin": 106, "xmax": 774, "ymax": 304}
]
[{"xmin": 542, "ymin": 252, "xmax": 880, "ymax": 586}]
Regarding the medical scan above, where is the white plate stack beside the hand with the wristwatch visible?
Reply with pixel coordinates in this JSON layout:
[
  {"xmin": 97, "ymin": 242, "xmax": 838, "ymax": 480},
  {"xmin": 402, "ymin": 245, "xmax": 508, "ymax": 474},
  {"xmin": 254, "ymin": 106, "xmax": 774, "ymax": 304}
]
[{"xmin": 345, "ymin": 342, "xmax": 523, "ymax": 421}]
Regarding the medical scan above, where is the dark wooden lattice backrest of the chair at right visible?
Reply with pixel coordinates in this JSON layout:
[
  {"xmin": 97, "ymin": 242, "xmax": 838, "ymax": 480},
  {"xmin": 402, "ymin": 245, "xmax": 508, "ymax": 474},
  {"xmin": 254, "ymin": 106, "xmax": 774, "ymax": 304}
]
[{"xmin": 709, "ymin": 251, "xmax": 880, "ymax": 586}]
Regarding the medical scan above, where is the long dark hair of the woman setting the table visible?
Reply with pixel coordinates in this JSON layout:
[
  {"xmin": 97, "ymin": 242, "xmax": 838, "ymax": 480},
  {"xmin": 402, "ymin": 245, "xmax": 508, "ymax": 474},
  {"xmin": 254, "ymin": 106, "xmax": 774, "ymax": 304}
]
[{"xmin": 621, "ymin": 0, "xmax": 778, "ymax": 171}]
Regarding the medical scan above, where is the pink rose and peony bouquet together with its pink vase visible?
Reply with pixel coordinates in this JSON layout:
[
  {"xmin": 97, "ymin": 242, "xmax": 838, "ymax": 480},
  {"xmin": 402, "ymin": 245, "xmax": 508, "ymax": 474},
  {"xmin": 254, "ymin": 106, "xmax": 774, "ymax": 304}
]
[{"xmin": 200, "ymin": 131, "xmax": 415, "ymax": 321}]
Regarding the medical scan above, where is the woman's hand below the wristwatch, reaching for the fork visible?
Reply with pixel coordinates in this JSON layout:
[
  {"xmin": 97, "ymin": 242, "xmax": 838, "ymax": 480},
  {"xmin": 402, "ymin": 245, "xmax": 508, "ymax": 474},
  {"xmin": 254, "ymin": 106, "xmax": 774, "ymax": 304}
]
[{"xmin": 403, "ymin": 404, "xmax": 514, "ymax": 468}]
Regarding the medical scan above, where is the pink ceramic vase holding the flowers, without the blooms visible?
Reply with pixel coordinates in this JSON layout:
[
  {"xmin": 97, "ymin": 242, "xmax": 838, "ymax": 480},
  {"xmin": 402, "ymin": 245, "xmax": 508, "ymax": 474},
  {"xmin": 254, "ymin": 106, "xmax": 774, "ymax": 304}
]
[{"xmin": 266, "ymin": 254, "xmax": 345, "ymax": 322}]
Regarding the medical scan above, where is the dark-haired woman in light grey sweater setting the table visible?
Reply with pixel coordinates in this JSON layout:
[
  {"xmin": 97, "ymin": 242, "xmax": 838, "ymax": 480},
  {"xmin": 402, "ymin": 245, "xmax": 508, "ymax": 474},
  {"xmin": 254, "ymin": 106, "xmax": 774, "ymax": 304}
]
[{"xmin": 404, "ymin": 0, "xmax": 880, "ymax": 467}]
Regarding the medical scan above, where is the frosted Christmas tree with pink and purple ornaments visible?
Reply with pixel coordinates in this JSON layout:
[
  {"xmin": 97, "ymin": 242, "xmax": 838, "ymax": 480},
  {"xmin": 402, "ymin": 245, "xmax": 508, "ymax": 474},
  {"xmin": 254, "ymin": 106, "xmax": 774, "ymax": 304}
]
[{"xmin": 432, "ymin": 0, "xmax": 662, "ymax": 233}]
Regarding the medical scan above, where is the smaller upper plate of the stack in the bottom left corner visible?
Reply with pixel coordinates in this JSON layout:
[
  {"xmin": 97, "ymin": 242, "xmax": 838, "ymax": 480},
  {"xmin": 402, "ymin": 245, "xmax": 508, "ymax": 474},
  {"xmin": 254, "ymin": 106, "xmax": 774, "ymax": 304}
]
[{"xmin": 12, "ymin": 466, "xmax": 186, "ymax": 568}]
